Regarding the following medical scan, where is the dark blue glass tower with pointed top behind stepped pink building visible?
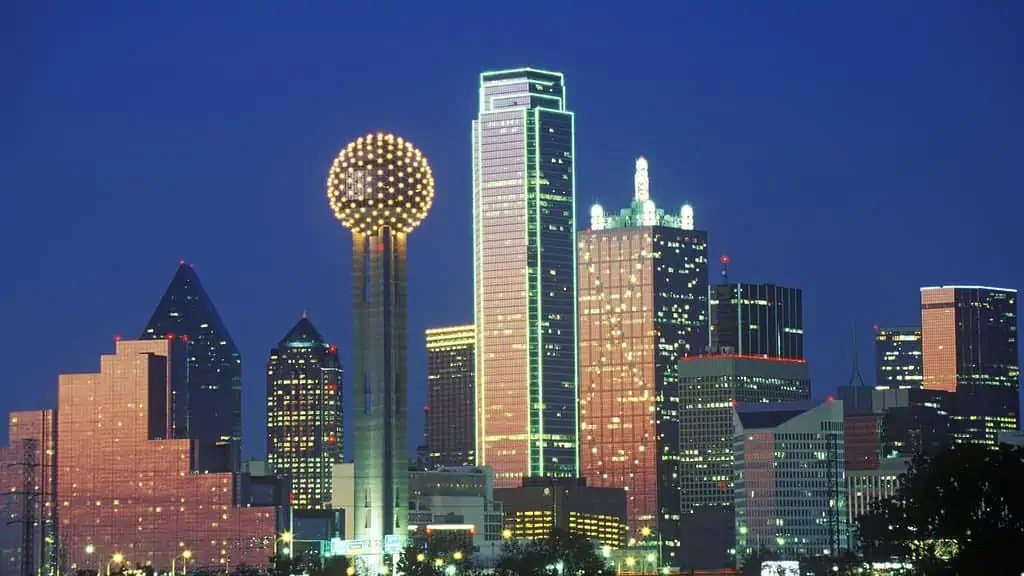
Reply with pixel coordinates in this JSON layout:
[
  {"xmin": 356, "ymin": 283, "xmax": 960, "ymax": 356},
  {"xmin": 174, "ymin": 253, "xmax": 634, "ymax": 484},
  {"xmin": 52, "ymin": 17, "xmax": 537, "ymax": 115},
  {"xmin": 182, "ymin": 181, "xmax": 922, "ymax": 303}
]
[{"xmin": 139, "ymin": 260, "xmax": 242, "ymax": 472}]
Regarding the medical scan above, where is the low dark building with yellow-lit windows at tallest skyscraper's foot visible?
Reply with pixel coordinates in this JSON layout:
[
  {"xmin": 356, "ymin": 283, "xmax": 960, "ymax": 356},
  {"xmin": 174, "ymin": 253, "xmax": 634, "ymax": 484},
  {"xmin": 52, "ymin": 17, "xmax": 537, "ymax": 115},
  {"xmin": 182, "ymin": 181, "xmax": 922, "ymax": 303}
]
[{"xmin": 495, "ymin": 479, "xmax": 626, "ymax": 548}]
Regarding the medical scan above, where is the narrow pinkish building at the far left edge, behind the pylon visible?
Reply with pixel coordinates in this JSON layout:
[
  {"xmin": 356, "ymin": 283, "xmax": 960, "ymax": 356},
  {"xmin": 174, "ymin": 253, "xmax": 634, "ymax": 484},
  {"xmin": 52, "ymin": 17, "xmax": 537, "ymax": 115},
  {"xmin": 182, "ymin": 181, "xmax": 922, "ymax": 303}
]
[{"xmin": 0, "ymin": 410, "xmax": 56, "ymax": 576}]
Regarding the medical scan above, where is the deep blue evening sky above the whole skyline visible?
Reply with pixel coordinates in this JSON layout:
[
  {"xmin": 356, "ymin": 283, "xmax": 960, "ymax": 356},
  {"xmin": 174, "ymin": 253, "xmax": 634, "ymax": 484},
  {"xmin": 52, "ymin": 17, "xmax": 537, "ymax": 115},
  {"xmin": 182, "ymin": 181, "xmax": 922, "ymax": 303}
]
[{"xmin": 0, "ymin": 0, "xmax": 1024, "ymax": 454}]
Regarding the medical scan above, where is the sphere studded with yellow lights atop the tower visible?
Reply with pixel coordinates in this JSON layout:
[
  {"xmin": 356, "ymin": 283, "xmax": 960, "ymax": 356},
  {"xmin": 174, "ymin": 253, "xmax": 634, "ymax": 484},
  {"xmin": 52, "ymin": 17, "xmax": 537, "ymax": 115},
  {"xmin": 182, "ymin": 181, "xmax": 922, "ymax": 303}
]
[{"xmin": 327, "ymin": 132, "xmax": 434, "ymax": 235}]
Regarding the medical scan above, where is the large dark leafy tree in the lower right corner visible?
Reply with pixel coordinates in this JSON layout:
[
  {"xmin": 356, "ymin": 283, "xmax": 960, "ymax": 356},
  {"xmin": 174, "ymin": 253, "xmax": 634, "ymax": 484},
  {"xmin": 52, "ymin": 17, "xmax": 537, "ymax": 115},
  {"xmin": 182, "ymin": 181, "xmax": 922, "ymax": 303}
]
[{"xmin": 857, "ymin": 445, "xmax": 1024, "ymax": 575}]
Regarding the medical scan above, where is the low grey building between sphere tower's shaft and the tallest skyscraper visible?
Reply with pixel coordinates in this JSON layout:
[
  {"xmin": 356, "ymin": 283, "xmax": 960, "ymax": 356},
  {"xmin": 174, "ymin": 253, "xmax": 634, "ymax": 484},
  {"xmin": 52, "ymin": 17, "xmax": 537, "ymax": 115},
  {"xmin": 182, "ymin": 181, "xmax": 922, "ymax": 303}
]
[{"xmin": 409, "ymin": 466, "xmax": 502, "ymax": 556}]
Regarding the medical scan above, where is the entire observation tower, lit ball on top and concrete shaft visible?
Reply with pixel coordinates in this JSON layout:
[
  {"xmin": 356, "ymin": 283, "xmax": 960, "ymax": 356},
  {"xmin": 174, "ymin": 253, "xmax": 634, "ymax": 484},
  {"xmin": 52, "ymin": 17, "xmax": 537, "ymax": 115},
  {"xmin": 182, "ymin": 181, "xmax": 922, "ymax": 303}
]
[{"xmin": 327, "ymin": 133, "xmax": 434, "ymax": 567}]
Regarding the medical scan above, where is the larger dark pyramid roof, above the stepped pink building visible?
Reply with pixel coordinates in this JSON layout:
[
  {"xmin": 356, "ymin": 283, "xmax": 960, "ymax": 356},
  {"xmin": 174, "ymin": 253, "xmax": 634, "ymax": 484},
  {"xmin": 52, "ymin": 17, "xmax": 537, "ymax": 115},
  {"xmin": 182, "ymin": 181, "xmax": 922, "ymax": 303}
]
[{"xmin": 140, "ymin": 260, "xmax": 239, "ymax": 356}]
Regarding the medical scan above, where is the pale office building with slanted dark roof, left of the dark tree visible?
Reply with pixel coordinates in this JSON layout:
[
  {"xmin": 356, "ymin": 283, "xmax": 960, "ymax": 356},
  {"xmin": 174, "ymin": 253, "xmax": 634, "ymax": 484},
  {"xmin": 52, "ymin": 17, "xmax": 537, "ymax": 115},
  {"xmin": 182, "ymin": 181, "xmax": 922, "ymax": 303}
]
[{"xmin": 733, "ymin": 401, "xmax": 849, "ymax": 565}]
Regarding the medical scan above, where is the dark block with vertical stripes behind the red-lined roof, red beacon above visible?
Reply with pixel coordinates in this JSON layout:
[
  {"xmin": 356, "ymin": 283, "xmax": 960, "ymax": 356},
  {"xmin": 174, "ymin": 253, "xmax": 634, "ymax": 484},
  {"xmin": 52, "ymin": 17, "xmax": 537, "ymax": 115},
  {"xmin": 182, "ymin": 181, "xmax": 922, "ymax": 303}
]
[{"xmin": 708, "ymin": 284, "xmax": 804, "ymax": 360}]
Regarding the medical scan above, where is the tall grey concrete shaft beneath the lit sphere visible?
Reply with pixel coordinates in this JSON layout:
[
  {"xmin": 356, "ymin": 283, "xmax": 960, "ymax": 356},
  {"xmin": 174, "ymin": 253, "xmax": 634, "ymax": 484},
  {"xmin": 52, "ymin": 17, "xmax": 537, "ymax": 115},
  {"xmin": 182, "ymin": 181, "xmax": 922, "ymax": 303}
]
[{"xmin": 352, "ymin": 228, "xmax": 409, "ymax": 549}]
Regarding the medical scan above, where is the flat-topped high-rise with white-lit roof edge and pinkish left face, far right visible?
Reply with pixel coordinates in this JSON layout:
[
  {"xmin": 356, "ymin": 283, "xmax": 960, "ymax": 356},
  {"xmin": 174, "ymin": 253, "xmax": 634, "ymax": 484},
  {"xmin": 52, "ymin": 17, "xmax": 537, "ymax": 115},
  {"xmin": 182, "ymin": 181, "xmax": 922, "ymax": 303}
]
[{"xmin": 921, "ymin": 286, "xmax": 1020, "ymax": 447}]
